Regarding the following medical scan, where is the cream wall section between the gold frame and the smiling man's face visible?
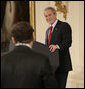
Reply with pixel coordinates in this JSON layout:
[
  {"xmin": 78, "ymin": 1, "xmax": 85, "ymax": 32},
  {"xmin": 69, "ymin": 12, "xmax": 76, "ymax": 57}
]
[{"xmin": 35, "ymin": 1, "xmax": 50, "ymax": 43}]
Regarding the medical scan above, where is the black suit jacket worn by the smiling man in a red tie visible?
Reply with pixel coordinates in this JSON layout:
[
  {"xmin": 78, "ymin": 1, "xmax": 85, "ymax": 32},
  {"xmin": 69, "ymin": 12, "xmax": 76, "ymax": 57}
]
[{"xmin": 46, "ymin": 20, "xmax": 72, "ymax": 72}]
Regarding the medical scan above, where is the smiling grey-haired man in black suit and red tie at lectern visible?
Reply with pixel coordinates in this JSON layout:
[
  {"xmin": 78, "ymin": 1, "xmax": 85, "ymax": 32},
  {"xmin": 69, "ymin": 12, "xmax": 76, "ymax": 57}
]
[{"xmin": 44, "ymin": 7, "xmax": 72, "ymax": 88}]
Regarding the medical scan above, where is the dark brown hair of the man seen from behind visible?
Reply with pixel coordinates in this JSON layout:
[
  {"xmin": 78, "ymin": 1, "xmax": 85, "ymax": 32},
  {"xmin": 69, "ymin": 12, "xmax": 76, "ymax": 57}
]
[{"xmin": 11, "ymin": 22, "xmax": 34, "ymax": 43}]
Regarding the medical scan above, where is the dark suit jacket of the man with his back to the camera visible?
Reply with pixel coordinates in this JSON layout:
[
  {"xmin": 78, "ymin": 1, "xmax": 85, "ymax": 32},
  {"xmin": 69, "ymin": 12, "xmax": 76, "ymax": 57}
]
[{"xmin": 1, "ymin": 46, "xmax": 57, "ymax": 88}]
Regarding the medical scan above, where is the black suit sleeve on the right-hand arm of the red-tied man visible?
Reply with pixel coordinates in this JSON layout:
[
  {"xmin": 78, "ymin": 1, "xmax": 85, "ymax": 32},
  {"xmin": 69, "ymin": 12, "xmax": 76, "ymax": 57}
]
[{"xmin": 58, "ymin": 23, "xmax": 72, "ymax": 50}]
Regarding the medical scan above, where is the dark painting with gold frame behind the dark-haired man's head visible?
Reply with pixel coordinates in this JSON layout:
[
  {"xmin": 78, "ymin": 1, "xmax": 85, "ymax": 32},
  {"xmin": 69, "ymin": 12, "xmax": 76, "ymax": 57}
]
[{"xmin": 1, "ymin": 1, "xmax": 35, "ymax": 55}]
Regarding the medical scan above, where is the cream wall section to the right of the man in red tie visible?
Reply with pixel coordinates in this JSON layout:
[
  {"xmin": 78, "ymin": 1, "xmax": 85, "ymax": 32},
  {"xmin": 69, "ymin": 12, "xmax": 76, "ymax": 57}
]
[{"xmin": 67, "ymin": 1, "xmax": 84, "ymax": 87}]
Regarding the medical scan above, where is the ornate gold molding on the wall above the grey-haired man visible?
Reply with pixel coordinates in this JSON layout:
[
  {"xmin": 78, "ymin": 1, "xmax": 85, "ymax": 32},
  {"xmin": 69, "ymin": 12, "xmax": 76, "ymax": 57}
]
[{"xmin": 55, "ymin": 1, "xmax": 68, "ymax": 20}]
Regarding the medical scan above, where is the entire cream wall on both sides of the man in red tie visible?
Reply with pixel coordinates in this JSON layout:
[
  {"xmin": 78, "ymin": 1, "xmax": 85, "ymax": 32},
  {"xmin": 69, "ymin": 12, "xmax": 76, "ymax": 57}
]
[{"xmin": 35, "ymin": 1, "xmax": 84, "ymax": 88}]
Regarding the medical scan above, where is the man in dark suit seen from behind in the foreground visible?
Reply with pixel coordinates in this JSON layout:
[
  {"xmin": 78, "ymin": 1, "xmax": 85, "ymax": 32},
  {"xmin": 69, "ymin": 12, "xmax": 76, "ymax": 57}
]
[{"xmin": 1, "ymin": 22, "xmax": 57, "ymax": 88}]
